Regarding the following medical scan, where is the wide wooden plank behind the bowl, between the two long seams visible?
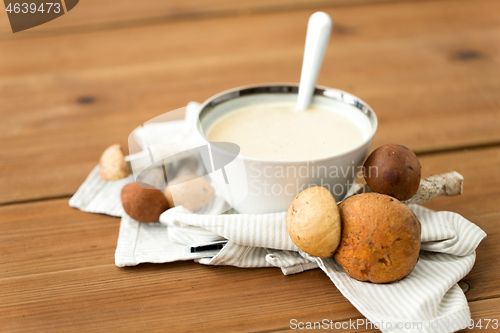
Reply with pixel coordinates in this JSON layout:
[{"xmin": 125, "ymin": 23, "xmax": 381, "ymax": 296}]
[{"xmin": 0, "ymin": 0, "xmax": 500, "ymax": 203}]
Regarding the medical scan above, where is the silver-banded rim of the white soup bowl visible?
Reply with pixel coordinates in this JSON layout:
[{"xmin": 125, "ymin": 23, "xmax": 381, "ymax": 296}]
[{"xmin": 195, "ymin": 83, "xmax": 378, "ymax": 165}]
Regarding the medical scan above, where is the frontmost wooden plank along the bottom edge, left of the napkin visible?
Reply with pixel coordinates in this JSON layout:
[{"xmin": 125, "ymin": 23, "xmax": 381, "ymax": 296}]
[{"xmin": 0, "ymin": 263, "xmax": 374, "ymax": 332}]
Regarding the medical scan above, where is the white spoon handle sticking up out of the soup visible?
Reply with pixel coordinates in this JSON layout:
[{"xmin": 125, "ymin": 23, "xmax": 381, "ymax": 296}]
[{"xmin": 297, "ymin": 12, "xmax": 333, "ymax": 110}]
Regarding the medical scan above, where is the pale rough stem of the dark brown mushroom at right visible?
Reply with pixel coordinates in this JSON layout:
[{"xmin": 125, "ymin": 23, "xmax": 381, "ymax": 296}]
[{"xmin": 352, "ymin": 171, "xmax": 464, "ymax": 205}]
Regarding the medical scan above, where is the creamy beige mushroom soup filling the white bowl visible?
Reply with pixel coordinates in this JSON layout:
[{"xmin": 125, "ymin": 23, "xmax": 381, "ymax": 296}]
[{"xmin": 206, "ymin": 101, "xmax": 369, "ymax": 161}]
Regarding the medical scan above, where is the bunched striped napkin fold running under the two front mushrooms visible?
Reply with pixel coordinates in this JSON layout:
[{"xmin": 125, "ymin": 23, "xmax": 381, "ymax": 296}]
[{"xmin": 160, "ymin": 205, "xmax": 486, "ymax": 332}]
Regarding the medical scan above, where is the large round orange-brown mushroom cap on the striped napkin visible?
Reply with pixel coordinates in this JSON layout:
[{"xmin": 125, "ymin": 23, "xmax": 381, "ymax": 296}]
[{"xmin": 334, "ymin": 193, "xmax": 421, "ymax": 283}]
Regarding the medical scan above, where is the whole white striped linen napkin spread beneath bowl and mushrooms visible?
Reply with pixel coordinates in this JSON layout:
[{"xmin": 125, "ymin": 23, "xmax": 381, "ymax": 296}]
[{"xmin": 69, "ymin": 103, "xmax": 486, "ymax": 332}]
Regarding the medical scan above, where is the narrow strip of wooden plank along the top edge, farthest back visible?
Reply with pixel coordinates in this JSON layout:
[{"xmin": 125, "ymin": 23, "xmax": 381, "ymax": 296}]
[{"xmin": 0, "ymin": 0, "xmax": 408, "ymax": 39}]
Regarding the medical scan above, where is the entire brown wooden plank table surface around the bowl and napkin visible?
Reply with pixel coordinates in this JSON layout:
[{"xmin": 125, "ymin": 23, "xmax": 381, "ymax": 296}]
[{"xmin": 0, "ymin": 0, "xmax": 500, "ymax": 332}]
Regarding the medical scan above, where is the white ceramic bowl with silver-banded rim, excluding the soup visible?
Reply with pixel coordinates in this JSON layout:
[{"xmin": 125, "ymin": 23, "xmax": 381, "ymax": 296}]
[{"xmin": 193, "ymin": 84, "xmax": 377, "ymax": 214}]
